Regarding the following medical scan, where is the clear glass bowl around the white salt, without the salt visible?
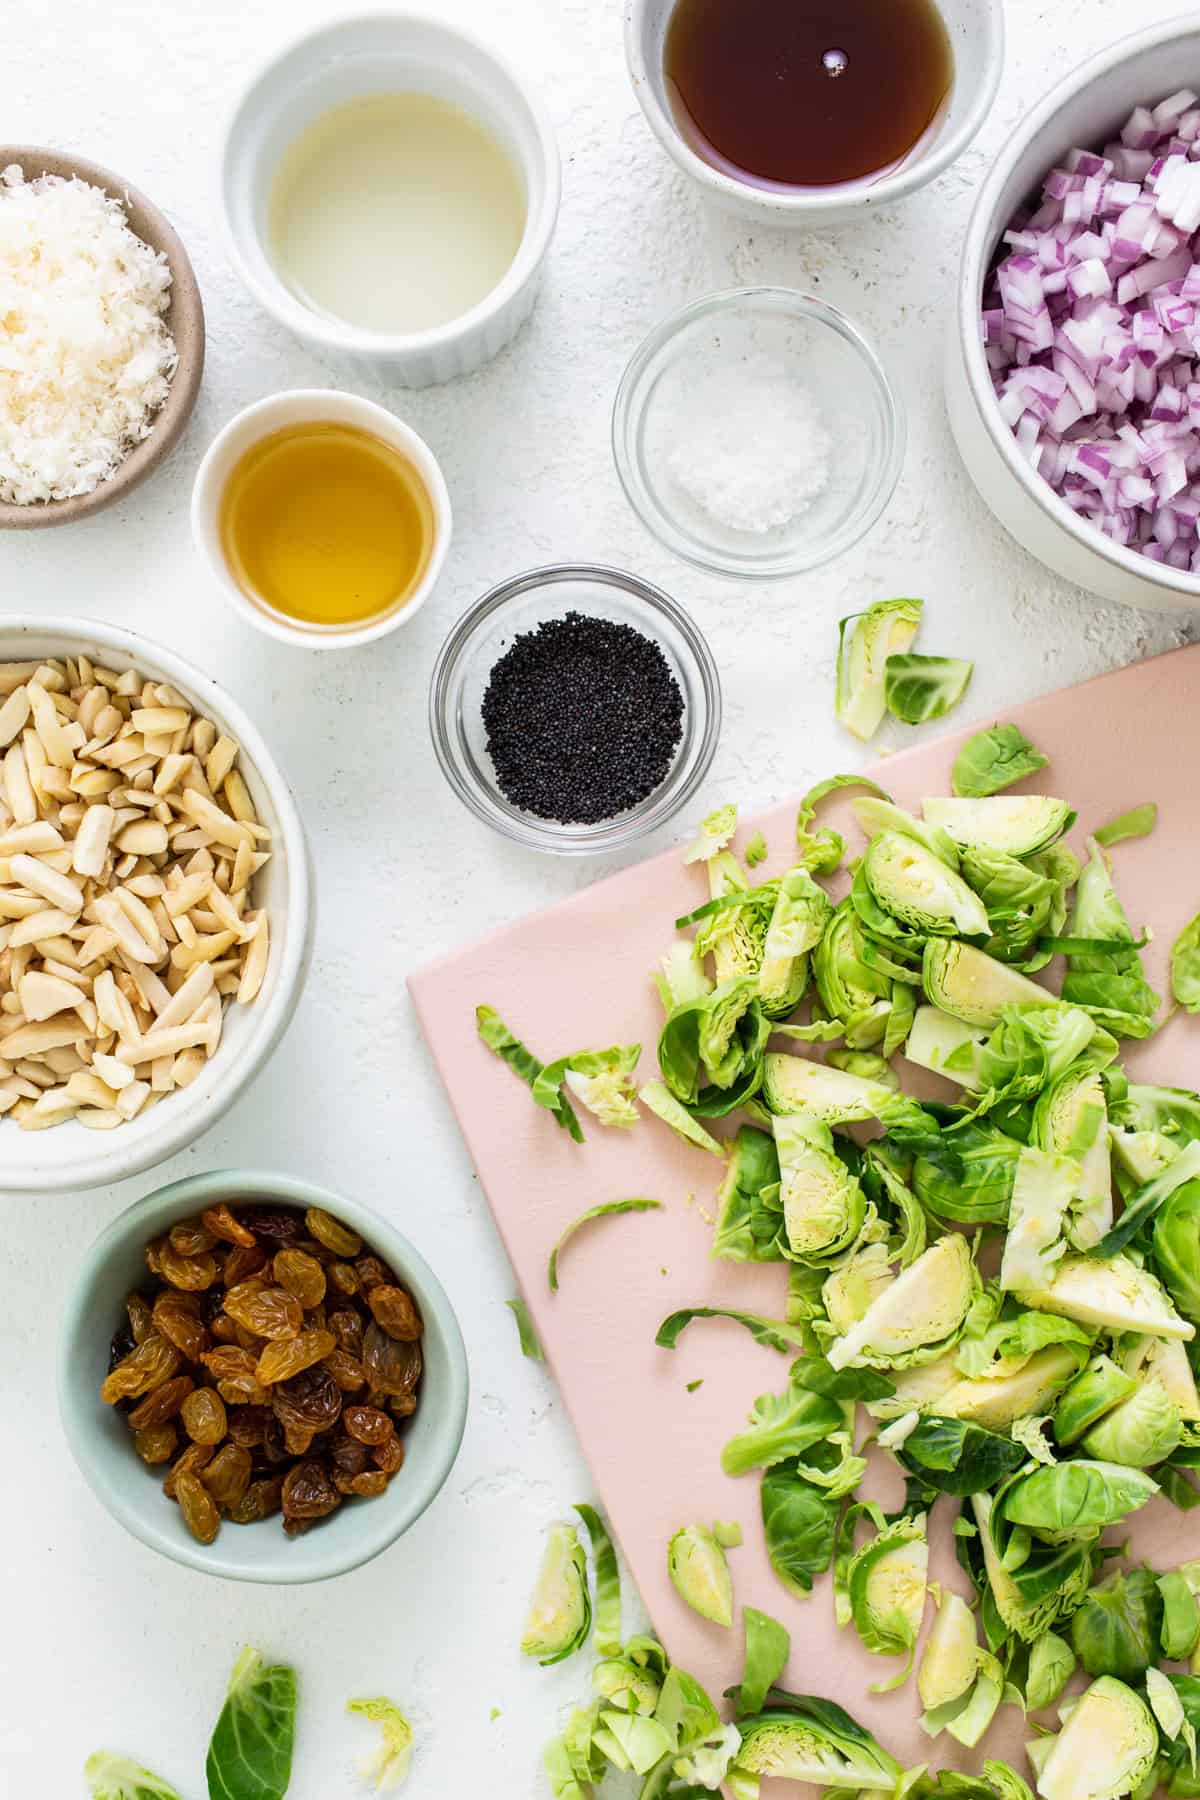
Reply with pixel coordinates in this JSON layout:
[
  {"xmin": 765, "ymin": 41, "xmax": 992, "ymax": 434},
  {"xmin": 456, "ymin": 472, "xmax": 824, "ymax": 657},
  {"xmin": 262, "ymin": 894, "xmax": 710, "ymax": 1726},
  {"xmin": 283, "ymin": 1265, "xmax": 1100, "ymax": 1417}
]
[{"xmin": 612, "ymin": 288, "xmax": 905, "ymax": 581}]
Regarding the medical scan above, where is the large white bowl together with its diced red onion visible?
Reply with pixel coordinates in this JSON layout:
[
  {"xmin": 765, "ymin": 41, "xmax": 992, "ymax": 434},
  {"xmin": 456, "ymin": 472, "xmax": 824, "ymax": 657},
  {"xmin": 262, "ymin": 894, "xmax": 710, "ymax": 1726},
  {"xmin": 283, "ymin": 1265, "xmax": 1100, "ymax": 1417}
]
[{"xmin": 946, "ymin": 14, "xmax": 1200, "ymax": 610}]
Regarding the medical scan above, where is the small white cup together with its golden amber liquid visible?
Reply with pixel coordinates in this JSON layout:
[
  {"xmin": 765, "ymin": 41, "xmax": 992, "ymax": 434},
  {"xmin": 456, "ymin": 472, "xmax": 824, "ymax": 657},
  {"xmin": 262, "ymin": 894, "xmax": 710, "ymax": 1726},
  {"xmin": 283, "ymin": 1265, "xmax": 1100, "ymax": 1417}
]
[{"xmin": 193, "ymin": 387, "xmax": 450, "ymax": 650}]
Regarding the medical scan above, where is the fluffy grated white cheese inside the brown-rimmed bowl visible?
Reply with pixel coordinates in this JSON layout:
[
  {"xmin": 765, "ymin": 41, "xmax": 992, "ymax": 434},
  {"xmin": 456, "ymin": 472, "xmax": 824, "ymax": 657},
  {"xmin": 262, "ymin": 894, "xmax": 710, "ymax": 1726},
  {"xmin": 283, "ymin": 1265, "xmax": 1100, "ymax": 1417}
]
[{"xmin": 0, "ymin": 164, "xmax": 178, "ymax": 506}]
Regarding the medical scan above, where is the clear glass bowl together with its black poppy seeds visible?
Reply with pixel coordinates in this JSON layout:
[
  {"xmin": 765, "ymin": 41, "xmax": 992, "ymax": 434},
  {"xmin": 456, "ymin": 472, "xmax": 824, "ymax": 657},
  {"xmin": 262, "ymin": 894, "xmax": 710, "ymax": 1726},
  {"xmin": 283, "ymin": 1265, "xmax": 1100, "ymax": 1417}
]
[{"xmin": 430, "ymin": 563, "xmax": 721, "ymax": 857}]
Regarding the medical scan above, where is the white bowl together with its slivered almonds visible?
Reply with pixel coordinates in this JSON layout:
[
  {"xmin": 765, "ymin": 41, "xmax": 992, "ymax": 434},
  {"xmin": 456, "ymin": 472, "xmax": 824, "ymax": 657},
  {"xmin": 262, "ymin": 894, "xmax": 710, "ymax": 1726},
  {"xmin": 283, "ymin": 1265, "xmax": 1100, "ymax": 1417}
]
[{"xmin": 0, "ymin": 617, "xmax": 313, "ymax": 1193}]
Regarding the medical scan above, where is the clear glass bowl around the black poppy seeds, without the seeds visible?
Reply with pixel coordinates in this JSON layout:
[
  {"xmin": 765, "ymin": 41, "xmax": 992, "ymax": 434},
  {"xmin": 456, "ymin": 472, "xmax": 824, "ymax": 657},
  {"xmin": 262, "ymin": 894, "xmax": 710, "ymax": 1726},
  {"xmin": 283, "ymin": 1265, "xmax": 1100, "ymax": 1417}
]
[{"xmin": 430, "ymin": 563, "xmax": 721, "ymax": 857}]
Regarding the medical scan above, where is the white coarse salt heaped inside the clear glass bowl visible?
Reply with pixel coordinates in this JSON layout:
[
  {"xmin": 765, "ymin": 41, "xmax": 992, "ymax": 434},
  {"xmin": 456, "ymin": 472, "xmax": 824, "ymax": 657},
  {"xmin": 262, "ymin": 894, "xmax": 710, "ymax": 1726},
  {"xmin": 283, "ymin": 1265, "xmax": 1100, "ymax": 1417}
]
[{"xmin": 667, "ymin": 351, "xmax": 833, "ymax": 536}]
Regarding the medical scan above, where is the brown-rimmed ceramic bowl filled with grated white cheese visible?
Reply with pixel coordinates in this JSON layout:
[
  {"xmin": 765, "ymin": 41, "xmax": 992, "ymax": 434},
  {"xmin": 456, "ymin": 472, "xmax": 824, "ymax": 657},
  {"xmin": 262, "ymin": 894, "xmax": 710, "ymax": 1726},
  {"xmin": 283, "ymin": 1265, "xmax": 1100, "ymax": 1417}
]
[{"xmin": 0, "ymin": 144, "xmax": 205, "ymax": 531}]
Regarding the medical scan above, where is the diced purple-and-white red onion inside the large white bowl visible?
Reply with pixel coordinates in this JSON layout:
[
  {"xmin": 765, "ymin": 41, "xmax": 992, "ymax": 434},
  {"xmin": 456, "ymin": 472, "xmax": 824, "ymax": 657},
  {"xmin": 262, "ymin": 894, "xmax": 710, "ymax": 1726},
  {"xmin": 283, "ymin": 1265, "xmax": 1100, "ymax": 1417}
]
[{"xmin": 981, "ymin": 88, "xmax": 1200, "ymax": 574}]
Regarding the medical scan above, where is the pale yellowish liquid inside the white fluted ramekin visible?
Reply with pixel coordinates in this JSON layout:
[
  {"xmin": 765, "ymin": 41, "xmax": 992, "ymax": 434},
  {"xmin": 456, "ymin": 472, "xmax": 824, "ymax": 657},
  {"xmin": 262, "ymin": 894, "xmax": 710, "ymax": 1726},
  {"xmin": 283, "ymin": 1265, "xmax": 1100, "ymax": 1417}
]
[{"xmin": 266, "ymin": 92, "xmax": 527, "ymax": 335}]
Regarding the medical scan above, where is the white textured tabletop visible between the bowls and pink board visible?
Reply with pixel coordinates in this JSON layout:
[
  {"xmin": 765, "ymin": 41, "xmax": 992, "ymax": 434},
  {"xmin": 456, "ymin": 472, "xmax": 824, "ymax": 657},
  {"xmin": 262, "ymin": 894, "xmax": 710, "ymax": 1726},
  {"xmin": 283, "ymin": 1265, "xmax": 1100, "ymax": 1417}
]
[{"xmin": 0, "ymin": 0, "xmax": 1187, "ymax": 1800}]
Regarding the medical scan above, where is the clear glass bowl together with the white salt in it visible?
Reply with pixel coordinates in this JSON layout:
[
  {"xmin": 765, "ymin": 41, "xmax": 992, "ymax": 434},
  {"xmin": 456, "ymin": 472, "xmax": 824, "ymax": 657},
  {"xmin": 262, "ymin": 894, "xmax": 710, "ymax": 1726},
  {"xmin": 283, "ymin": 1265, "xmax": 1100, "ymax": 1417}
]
[{"xmin": 612, "ymin": 288, "xmax": 905, "ymax": 581}]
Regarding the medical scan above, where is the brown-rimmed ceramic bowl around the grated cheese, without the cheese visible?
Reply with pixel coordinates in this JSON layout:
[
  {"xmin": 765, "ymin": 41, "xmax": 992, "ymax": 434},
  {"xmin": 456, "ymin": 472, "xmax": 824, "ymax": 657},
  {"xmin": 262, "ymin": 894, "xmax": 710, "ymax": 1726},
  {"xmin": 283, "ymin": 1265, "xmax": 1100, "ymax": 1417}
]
[{"xmin": 0, "ymin": 144, "xmax": 205, "ymax": 531}]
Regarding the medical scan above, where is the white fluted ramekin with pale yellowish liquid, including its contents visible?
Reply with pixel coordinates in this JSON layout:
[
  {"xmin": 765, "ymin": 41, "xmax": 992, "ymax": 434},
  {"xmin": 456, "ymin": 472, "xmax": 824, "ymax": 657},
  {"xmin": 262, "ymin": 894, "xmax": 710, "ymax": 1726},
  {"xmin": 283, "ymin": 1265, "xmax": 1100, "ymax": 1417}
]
[{"xmin": 221, "ymin": 13, "xmax": 561, "ymax": 387}]
